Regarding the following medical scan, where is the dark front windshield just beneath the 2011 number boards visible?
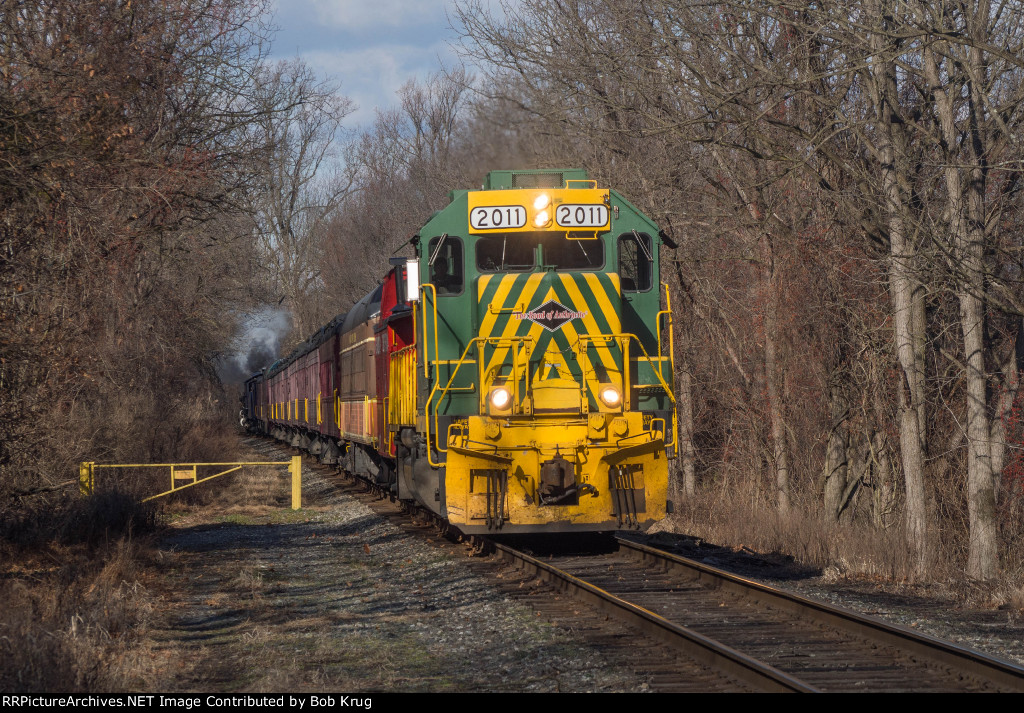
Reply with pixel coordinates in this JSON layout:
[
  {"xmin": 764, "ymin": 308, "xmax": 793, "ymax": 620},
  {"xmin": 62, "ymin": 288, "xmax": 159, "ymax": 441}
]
[{"xmin": 476, "ymin": 232, "xmax": 604, "ymax": 272}]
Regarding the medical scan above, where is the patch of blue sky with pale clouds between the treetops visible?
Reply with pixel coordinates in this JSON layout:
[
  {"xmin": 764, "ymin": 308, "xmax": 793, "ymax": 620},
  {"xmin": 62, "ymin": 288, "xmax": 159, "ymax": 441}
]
[{"xmin": 270, "ymin": 0, "xmax": 466, "ymax": 129}]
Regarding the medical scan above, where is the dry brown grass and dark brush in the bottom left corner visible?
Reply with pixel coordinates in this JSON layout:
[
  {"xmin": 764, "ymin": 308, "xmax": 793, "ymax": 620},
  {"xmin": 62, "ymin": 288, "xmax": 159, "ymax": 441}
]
[{"xmin": 0, "ymin": 496, "xmax": 155, "ymax": 691}]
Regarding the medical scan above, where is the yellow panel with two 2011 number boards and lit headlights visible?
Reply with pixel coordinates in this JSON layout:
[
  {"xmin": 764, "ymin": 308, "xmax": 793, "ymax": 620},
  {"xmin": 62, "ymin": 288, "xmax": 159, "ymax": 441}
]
[{"xmin": 468, "ymin": 188, "xmax": 611, "ymax": 237}]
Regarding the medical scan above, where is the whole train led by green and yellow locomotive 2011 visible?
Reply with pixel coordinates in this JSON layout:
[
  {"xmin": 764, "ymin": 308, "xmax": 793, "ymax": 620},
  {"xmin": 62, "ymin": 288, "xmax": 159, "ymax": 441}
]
[{"xmin": 242, "ymin": 170, "xmax": 677, "ymax": 535}]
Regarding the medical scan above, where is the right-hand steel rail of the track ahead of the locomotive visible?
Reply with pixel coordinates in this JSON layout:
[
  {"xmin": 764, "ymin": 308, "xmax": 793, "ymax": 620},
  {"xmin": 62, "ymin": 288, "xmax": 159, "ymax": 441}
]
[{"xmin": 615, "ymin": 537, "xmax": 1024, "ymax": 691}]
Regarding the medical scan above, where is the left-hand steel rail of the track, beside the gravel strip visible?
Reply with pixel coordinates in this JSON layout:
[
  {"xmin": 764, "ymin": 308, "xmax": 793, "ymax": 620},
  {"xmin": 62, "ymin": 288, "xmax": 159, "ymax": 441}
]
[{"xmin": 493, "ymin": 543, "xmax": 818, "ymax": 693}]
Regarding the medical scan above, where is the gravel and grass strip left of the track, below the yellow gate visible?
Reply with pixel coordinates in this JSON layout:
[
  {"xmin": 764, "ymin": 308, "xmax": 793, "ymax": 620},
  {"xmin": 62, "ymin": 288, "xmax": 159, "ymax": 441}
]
[{"xmin": 153, "ymin": 442, "xmax": 663, "ymax": 693}]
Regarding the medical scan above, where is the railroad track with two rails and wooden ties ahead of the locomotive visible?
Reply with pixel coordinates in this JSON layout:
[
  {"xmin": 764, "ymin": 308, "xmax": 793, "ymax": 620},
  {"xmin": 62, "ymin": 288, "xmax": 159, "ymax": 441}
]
[{"xmin": 496, "ymin": 538, "xmax": 1024, "ymax": 693}]
